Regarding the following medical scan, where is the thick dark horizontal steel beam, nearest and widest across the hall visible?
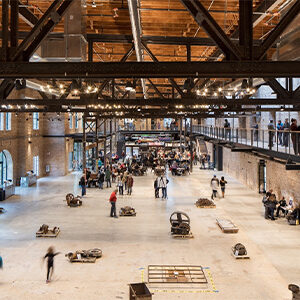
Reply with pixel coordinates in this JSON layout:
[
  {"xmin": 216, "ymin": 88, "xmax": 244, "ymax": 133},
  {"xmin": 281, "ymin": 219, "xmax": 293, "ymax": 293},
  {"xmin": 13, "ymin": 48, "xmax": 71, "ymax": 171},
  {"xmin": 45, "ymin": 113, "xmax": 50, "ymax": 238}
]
[{"xmin": 0, "ymin": 61, "xmax": 300, "ymax": 80}]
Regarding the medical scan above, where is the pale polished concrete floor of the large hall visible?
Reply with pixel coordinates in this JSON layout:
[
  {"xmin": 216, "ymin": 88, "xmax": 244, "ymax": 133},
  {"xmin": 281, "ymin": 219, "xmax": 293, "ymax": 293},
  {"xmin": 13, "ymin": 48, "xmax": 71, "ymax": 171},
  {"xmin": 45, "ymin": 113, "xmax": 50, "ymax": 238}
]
[{"xmin": 0, "ymin": 167, "xmax": 300, "ymax": 300}]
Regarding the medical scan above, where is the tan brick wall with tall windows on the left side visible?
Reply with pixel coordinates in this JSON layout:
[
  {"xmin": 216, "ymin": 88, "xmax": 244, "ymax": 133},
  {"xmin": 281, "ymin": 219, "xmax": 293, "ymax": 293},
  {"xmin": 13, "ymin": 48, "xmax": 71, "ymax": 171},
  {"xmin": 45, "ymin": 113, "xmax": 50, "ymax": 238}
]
[{"xmin": 0, "ymin": 89, "xmax": 82, "ymax": 180}]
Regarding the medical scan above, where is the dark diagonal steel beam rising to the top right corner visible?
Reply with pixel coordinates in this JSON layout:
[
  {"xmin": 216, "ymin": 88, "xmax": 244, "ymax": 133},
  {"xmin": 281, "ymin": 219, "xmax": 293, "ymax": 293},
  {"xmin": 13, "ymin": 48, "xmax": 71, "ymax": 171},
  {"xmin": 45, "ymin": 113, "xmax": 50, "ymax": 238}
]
[{"xmin": 257, "ymin": 1, "xmax": 300, "ymax": 59}]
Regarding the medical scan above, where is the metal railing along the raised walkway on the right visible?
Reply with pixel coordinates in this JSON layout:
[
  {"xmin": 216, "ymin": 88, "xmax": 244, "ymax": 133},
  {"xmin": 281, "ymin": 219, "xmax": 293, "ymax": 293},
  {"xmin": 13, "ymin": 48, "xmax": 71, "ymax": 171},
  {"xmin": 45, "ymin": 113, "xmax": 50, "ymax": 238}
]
[{"xmin": 193, "ymin": 125, "xmax": 300, "ymax": 155}]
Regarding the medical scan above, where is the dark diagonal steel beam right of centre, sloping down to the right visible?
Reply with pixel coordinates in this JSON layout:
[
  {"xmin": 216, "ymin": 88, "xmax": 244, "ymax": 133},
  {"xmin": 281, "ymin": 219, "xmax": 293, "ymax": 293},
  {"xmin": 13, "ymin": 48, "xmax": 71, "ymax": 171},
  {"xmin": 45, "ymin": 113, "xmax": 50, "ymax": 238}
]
[{"xmin": 181, "ymin": 0, "xmax": 241, "ymax": 60}]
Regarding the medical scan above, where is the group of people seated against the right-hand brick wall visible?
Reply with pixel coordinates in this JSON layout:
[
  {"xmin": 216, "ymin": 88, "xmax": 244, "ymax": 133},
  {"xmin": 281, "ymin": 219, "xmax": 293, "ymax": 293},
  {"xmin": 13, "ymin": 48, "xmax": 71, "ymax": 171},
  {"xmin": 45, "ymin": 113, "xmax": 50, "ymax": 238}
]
[{"xmin": 262, "ymin": 189, "xmax": 300, "ymax": 225}]
